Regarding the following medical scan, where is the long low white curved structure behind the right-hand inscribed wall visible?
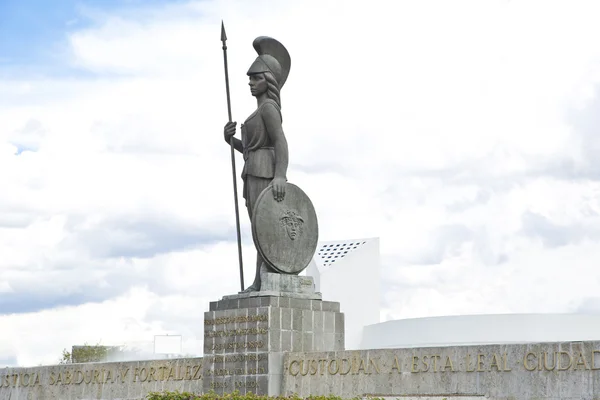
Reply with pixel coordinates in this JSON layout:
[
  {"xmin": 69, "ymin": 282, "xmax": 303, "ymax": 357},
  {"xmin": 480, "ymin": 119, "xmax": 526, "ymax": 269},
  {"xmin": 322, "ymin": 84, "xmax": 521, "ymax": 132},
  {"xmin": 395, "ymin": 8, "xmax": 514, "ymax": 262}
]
[{"xmin": 360, "ymin": 314, "xmax": 600, "ymax": 349}]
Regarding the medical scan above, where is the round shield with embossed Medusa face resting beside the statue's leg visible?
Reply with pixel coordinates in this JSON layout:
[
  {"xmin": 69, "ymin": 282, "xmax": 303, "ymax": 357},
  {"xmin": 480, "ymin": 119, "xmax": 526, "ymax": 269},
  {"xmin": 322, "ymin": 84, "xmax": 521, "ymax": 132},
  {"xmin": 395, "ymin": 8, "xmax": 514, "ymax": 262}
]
[{"xmin": 252, "ymin": 183, "xmax": 319, "ymax": 274}]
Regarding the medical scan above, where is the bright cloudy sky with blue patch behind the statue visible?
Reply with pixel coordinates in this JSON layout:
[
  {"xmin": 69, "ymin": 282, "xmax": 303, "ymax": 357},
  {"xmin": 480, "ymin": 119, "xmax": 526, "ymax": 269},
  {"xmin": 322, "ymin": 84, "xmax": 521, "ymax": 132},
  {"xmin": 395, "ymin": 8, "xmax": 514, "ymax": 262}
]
[{"xmin": 0, "ymin": 0, "xmax": 600, "ymax": 366}]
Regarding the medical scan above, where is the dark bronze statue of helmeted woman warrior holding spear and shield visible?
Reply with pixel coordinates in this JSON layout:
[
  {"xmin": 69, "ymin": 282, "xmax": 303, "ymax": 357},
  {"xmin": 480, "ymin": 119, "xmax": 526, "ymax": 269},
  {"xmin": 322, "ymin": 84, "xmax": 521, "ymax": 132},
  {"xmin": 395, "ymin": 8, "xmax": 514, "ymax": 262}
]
[{"xmin": 222, "ymin": 33, "xmax": 317, "ymax": 293}]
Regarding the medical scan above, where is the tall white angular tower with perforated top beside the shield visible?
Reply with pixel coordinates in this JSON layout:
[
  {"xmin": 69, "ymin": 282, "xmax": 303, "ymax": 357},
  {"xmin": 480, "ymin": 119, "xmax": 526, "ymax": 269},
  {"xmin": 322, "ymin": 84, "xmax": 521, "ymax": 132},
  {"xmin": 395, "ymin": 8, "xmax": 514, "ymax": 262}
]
[{"xmin": 306, "ymin": 238, "xmax": 380, "ymax": 350}]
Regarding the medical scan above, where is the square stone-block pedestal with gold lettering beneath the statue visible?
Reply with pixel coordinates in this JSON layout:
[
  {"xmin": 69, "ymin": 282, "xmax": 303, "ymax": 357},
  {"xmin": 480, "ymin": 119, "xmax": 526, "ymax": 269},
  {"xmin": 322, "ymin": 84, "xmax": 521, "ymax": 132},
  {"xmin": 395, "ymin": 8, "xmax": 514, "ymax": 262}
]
[{"xmin": 203, "ymin": 274, "xmax": 344, "ymax": 396}]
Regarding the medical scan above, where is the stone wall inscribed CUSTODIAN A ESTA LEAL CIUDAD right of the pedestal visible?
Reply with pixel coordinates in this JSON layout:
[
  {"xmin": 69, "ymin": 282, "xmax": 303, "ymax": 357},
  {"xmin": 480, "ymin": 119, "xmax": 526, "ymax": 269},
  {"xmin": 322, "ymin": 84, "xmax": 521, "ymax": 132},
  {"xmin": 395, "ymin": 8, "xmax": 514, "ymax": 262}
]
[{"xmin": 283, "ymin": 342, "xmax": 600, "ymax": 400}]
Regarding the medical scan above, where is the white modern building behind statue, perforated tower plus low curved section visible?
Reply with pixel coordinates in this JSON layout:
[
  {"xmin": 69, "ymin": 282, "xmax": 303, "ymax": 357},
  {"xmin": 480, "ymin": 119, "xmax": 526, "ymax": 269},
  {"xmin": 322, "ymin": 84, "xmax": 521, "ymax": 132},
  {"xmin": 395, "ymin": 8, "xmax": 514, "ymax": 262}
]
[{"xmin": 306, "ymin": 238, "xmax": 600, "ymax": 350}]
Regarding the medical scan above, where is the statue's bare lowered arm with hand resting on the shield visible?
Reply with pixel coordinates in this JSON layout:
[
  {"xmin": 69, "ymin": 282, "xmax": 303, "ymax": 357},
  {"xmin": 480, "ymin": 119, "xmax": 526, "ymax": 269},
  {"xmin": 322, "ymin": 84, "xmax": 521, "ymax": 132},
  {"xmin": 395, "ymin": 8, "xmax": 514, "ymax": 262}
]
[{"xmin": 262, "ymin": 104, "xmax": 289, "ymax": 201}]
